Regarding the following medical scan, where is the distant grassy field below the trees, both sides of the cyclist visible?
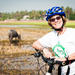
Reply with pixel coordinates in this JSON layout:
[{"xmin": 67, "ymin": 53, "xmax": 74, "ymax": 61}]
[{"xmin": 0, "ymin": 21, "xmax": 75, "ymax": 27}]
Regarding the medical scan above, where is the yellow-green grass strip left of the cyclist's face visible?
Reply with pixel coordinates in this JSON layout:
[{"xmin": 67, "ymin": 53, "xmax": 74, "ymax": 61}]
[{"xmin": 0, "ymin": 20, "xmax": 47, "ymax": 25}]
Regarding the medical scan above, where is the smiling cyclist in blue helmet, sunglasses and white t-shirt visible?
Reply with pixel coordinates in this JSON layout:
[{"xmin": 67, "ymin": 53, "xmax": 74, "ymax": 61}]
[{"xmin": 32, "ymin": 6, "xmax": 75, "ymax": 75}]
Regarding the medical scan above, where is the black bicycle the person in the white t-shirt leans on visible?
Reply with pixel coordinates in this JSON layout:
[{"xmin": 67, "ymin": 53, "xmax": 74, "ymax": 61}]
[{"xmin": 33, "ymin": 49, "xmax": 70, "ymax": 75}]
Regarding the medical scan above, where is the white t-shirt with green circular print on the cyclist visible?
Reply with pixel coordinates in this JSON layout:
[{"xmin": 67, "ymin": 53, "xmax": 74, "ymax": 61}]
[{"xmin": 38, "ymin": 28, "xmax": 75, "ymax": 74}]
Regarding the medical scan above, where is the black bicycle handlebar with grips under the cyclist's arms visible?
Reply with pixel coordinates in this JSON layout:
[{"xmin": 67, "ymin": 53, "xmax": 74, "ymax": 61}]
[{"xmin": 33, "ymin": 49, "xmax": 75, "ymax": 73}]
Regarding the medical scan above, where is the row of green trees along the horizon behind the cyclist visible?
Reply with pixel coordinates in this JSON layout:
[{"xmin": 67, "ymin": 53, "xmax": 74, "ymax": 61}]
[{"xmin": 0, "ymin": 6, "xmax": 75, "ymax": 21}]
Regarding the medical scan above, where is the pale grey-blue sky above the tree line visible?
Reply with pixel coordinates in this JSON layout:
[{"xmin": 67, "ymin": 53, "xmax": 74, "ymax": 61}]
[{"xmin": 0, "ymin": 0, "xmax": 75, "ymax": 12}]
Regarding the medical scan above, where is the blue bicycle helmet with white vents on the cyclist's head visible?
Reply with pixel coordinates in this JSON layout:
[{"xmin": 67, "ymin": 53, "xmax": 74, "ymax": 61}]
[{"xmin": 45, "ymin": 7, "xmax": 66, "ymax": 21}]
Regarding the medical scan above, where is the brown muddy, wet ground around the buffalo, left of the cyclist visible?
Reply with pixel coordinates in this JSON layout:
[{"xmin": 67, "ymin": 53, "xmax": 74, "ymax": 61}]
[{"xmin": 0, "ymin": 28, "xmax": 55, "ymax": 75}]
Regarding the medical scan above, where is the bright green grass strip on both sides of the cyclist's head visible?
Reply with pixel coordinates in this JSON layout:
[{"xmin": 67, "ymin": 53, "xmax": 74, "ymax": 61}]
[{"xmin": 0, "ymin": 21, "xmax": 75, "ymax": 28}]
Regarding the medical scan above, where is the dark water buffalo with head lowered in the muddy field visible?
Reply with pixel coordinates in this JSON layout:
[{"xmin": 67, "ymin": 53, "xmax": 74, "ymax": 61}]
[{"xmin": 8, "ymin": 30, "xmax": 21, "ymax": 43}]
